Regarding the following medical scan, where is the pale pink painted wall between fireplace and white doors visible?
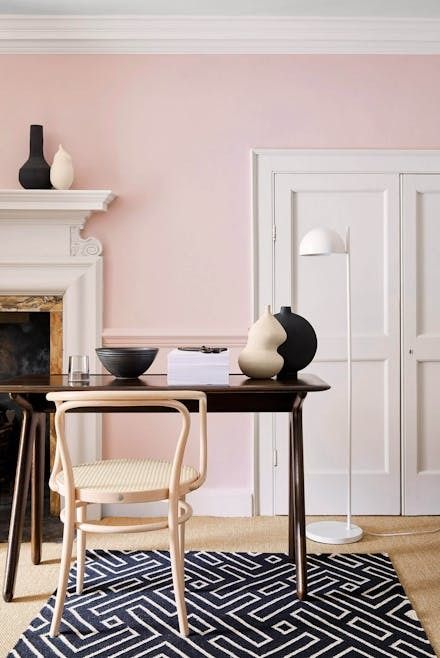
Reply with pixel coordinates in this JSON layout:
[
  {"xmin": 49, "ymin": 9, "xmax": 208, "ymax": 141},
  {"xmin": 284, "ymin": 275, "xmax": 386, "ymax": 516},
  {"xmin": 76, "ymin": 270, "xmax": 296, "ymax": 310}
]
[{"xmin": 0, "ymin": 55, "xmax": 440, "ymax": 488}]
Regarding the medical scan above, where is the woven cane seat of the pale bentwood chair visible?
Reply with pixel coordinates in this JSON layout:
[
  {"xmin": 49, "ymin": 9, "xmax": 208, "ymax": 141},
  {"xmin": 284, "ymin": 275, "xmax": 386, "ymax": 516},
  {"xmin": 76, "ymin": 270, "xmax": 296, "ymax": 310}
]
[{"xmin": 56, "ymin": 459, "xmax": 199, "ymax": 503}]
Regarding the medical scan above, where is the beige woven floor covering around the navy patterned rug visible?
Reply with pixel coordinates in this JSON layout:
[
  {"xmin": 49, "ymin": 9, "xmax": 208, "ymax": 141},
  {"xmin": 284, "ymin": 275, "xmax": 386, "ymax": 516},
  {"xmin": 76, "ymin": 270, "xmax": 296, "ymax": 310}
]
[{"xmin": 0, "ymin": 516, "xmax": 440, "ymax": 656}]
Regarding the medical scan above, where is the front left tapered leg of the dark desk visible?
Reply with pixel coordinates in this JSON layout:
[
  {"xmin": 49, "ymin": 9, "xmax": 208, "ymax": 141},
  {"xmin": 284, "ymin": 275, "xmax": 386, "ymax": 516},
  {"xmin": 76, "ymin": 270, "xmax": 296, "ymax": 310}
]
[{"xmin": 3, "ymin": 396, "xmax": 38, "ymax": 601}]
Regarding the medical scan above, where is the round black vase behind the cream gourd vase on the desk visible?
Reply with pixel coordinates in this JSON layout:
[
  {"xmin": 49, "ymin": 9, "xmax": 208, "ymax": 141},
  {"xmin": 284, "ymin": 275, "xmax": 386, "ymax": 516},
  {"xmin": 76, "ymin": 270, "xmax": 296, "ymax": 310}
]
[{"xmin": 275, "ymin": 306, "xmax": 318, "ymax": 379}]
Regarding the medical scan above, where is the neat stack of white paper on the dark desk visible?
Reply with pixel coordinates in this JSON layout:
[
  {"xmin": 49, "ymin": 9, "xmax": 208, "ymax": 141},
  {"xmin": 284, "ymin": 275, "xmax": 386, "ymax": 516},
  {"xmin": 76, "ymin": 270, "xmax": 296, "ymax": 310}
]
[{"xmin": 168, "ymin": 349, "xmax": 229, "ymax": 386}]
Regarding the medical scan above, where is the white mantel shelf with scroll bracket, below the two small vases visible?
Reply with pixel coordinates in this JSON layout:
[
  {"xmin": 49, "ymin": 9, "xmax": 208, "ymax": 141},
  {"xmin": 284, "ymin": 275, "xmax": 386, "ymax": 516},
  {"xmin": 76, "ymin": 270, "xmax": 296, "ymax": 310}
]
[{"xmin": 0, "ymin": 190, "xmax": 115, "ymax": 259}]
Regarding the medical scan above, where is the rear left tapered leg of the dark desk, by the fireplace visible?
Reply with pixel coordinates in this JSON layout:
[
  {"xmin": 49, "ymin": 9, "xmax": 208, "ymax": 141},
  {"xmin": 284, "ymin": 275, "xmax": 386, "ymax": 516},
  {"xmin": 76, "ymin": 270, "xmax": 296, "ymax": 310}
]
[{"xmin": 31, "ymin": 413, "xmax": 46, "ymax": 564}]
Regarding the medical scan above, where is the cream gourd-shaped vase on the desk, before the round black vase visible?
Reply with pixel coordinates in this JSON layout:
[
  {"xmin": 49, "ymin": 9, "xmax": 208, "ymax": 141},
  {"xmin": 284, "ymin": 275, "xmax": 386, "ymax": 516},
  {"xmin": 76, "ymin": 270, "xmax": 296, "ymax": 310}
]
[{"xmin": 238, "ymin": 306, "xmax": 287, "ymax": 379}]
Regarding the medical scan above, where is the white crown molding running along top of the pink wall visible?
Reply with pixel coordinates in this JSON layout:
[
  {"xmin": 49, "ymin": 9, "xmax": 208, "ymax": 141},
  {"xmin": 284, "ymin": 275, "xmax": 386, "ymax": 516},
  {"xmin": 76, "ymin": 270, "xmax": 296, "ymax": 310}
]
[{"xmin": 0, "ymin": 14, "xmax": 440, "ymax": 54}]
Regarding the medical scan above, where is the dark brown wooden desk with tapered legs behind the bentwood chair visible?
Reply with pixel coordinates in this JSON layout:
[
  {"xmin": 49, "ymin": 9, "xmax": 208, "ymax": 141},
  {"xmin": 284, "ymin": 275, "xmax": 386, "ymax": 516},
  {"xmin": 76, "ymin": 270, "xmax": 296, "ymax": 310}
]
[{"xmin": 0, "ymin": 375, "xmax": 330, "ymax": 601}]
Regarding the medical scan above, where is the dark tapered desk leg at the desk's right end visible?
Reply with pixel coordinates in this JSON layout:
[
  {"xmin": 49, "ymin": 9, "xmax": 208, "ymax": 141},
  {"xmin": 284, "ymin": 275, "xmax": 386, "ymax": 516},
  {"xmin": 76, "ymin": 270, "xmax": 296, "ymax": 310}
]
[{"xmin": 290, "ymin": 393, "xmax": 307, "ymax": 600}]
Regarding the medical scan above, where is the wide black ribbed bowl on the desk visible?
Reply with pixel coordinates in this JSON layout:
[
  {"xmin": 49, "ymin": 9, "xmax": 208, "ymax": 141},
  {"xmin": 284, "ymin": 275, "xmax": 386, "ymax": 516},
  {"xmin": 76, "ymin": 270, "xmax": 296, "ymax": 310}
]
[{"xmin": 96, "ymin": 347, "xmax": 159, "ymax": 379}]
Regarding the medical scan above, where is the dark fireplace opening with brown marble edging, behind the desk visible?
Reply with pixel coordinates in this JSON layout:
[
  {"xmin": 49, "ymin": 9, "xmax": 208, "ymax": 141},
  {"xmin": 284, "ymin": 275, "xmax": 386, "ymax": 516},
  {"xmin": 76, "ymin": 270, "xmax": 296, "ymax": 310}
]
[{"xmin": 0, "ymin": 298, "xmax": 62, "ymax": 541}]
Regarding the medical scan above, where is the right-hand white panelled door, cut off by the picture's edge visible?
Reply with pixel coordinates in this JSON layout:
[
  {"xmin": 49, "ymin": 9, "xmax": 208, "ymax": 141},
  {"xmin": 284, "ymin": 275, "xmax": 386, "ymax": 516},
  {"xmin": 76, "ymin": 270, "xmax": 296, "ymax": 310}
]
[{"xmin": 402, "ymin": 175, "xmax": 440, "ymax": 514}]
